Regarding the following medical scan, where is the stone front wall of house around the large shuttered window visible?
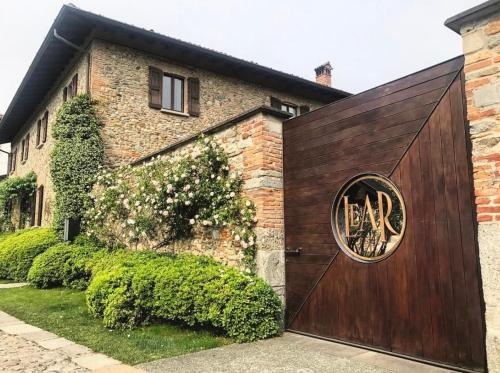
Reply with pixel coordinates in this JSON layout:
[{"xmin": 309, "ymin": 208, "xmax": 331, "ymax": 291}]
[{"xmin": 90, "ymin": 40, "xmax": 321, "ymax": 164}]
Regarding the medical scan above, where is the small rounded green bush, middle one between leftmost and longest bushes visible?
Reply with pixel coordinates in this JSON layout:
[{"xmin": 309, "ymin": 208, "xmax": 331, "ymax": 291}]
[{"xmin": 28, "ymin": 243, "xmax": 74, "ymax": 288}]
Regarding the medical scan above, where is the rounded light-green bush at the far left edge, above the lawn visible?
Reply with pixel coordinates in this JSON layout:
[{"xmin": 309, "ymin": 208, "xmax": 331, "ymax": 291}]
[{"xmin": 0, "ymin": 228, "xmax": 58, "ymax": 281}]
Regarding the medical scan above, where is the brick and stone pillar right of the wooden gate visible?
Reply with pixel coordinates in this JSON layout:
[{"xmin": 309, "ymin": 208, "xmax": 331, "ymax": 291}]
[{"xmin": 461, "ymin": 11, "xmax": 500, "ymax": 372}]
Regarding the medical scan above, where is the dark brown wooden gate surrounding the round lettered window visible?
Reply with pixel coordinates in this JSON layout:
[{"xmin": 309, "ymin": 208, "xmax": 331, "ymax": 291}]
[{"xmin": 283, "ymin": 57, "xmax": 485, "ymax": 370}]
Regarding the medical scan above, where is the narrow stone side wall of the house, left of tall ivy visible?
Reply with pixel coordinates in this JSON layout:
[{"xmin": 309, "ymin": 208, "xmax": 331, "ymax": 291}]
[{"xmin": 11, "ymin": 54, "xmax": 88, "ymax": 226}]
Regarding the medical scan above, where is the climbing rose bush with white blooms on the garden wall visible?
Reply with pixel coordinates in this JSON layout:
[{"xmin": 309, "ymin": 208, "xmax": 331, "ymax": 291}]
[{"xmin": 84, "ymin": 137, "xmax": 256, "ymax": 270}]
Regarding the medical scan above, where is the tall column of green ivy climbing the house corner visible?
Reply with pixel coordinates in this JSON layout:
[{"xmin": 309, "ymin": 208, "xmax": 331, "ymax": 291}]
[{"xmin": 50, "ymin": 94, "xmax": 104, "ymax": 233}]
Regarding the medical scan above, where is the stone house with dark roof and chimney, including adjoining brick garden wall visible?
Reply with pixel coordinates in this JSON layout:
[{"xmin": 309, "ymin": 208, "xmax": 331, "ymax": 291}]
[{"xmin": 0, "ymin": 5, "xmax": 349, "ymax": 287}]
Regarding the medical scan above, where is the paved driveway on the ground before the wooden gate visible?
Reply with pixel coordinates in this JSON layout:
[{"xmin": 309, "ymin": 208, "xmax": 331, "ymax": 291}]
[{"xmin": 138, "ymin": 333, "xmax": 449, "ymax": 373}]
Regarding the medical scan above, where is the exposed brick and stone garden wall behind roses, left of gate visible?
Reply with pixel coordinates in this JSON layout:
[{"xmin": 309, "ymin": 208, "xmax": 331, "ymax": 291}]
[{"xmin": 131, "ymin": 109, "xmax": 285, "ymax": 296}]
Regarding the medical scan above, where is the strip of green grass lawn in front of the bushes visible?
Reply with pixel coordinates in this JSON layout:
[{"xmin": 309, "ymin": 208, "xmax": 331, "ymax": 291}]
[{"xmin": 0, "ymin": 287, "xmax": 231, "ymax": 365}]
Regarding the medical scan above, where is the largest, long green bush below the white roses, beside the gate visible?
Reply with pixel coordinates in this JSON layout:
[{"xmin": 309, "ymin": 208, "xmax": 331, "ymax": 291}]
[{"xmin": 86, "ymin": 254, "xmax": 282, "ymax": 342}]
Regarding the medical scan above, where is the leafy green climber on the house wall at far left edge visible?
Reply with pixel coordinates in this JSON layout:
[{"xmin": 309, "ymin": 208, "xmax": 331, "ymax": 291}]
[{"xmin": 0, "ymin": 172, "xmax": 36, "ymax": 232}]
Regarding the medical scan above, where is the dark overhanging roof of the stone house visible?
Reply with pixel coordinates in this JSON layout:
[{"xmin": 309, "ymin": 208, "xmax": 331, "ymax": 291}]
[{"xmin": 0, "ymin": 5, "xmax": 350, "ymax": 143}]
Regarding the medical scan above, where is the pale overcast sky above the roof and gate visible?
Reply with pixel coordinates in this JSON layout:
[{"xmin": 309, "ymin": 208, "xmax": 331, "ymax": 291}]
[{"xmin": 0, "ymin": 0, "xmax": 482, "ymax": 113}]
